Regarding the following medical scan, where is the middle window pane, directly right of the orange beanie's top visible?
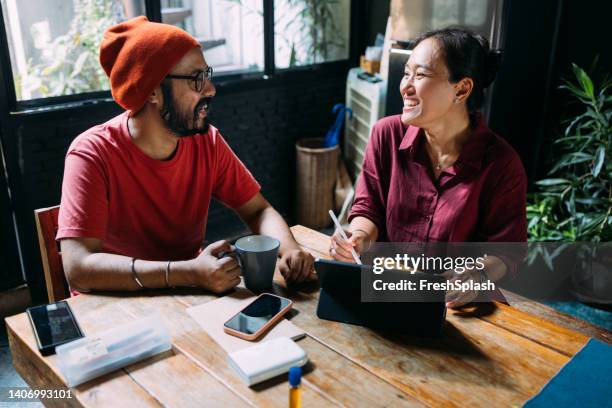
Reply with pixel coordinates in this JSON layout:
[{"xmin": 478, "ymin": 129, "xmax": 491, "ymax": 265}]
[{"xmin": 161, "ymin": 0, "xmax": 264, "ymax": 75}]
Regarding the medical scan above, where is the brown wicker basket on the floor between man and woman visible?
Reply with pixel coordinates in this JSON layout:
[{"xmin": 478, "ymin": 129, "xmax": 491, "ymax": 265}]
[{"xmin": 295, "ymin": 138, "xmax": 340, "ymax": 229}]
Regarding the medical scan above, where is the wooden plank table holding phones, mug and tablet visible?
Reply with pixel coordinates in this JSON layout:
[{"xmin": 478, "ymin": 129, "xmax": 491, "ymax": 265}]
[{"xmin": 7, "ymin": 226, "xmax": 604, "ymax": 408}]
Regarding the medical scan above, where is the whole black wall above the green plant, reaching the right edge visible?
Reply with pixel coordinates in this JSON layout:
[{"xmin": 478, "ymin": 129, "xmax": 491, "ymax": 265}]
[{"xmin": 490, "ymin": 0, "xmax": 612, "ymax": 183}]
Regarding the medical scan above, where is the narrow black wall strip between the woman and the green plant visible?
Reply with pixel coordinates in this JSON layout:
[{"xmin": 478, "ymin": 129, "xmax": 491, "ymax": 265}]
[{"xmin": 482, "ymin": 0, "xmax": 561, "ymax": 181}]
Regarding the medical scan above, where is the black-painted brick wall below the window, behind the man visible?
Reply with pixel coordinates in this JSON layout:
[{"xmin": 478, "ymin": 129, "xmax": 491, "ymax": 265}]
[{"xmin": 1, "ymin": 73, "xmax": 346, "ymax": 300}]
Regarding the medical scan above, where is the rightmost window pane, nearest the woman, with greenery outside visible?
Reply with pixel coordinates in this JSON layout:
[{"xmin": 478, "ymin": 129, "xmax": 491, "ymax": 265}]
[{"xmin": 274, "ymin": 0, "xmax": 351, "ymax": 68}]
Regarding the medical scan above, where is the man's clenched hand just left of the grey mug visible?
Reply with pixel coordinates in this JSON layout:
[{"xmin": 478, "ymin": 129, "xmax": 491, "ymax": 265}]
[{"xmin": 190, "ymin": 241, "xmax": 241, "ymax": 293}]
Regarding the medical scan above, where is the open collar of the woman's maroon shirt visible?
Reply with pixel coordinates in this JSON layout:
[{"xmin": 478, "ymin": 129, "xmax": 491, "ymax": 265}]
[{"xmin": 399, "ymin": 113, "xmax": 492, "ymax": 170}]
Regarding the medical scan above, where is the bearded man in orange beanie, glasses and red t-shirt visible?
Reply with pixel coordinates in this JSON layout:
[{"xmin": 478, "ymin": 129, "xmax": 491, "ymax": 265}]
[{"xmin": 56, "ymin": 17, "xmax": 313, "ymax": 293}]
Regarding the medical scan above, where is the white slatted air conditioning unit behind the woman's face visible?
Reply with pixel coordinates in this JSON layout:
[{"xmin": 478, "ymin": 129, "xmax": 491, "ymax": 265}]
[{"xmin": 344, "ymin": 68, "xmax": 387, "ymax": 180}]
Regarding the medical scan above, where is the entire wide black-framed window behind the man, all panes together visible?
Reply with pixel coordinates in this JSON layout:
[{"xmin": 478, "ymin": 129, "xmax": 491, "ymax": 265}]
[{"xmin": 0, "ymin": 0, "xmax": 352, "ymax": 109}]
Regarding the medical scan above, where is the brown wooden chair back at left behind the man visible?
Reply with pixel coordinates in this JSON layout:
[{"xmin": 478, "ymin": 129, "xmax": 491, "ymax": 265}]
[{"xmin": 34, "ymin": 205, "xmax": 70, "ymax": 303}]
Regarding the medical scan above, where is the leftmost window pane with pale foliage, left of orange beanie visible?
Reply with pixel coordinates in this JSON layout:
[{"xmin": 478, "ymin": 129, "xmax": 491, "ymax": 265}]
[{"xmin": 0, "ymin": 0, "xmax": 144, "ymax": 101}]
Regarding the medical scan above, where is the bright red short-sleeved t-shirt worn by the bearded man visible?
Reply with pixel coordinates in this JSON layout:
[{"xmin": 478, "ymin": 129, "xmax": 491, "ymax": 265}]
[{"xmin": 56, "ymin": 113, "xmax": 260, "ymax": 260}]
